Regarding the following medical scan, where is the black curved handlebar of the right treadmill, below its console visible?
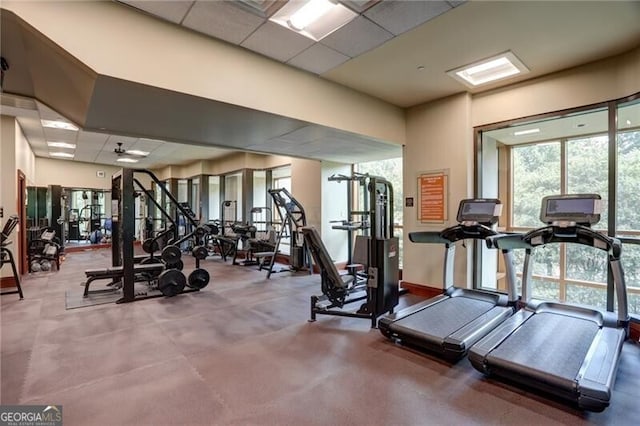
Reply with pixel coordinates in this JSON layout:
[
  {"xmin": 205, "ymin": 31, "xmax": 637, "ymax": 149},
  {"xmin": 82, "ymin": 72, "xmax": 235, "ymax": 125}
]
[{"xmin": 522, "ymin": 225, "xmax": 622, "ymax": 261}]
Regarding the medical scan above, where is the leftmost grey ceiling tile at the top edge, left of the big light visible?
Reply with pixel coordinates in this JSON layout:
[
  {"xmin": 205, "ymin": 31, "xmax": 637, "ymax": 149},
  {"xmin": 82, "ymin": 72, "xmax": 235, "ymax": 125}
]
[{"xmin": 182, "ymin": 1, "xmax": 265, "ymax": 44}]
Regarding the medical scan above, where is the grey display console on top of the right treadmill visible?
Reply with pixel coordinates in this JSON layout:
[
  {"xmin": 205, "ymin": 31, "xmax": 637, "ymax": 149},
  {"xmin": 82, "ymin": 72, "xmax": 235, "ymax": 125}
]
[{"xmin": 540, "ymin": 194, "xmax": 602, "ymax": 226}]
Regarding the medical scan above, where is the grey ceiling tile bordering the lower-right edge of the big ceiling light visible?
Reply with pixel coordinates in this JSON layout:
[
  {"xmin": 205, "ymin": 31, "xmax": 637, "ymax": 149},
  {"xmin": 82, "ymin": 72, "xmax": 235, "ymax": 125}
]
[{"xmin": 320, "ymin": 16, "xmax": 393, "ymax": 58}]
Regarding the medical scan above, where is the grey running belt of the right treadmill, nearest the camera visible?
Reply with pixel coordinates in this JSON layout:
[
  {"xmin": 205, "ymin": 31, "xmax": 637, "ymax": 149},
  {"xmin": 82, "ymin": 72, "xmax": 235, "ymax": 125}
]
[{"xmin": 487, "ymin": 312, "xmax": 599, "ymax": 381}]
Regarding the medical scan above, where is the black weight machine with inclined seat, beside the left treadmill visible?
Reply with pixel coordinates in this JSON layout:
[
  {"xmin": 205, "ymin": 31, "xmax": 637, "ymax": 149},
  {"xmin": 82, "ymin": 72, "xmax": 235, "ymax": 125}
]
[{"xmin": 302, "ymin": 173, "xmax": 400, "ymax": 327}]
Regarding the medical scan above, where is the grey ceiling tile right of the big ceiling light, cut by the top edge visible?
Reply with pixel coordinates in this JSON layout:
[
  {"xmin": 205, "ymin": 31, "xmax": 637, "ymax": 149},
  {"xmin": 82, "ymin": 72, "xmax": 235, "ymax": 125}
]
[{"xmin": 364, "ymin": 1, "xmax": 451, "ymax": 35}]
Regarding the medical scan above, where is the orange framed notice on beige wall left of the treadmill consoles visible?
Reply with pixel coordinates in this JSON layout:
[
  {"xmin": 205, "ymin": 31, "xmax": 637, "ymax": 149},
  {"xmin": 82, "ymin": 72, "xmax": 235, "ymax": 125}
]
[{"xmin": 418, "ymin": 173, "xmax": 448, "ymax": 223}]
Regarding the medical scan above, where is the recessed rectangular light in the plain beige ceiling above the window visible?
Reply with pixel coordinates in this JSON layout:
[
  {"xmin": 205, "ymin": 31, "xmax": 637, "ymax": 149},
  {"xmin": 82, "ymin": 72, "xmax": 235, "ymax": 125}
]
[{"xmin": 447, "ymin": 52, "xmax": 529, "ymax": 87}]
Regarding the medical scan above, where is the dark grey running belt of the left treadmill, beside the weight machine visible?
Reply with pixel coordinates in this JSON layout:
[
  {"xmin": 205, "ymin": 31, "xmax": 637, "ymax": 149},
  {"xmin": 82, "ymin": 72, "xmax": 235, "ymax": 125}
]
[{"xmin": 390, "ymin": 296, "xmax": 495, "ymax": 340}]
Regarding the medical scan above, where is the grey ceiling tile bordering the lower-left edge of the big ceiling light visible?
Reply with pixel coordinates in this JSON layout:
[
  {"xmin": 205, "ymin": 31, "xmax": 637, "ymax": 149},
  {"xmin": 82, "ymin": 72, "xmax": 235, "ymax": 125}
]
[{"xmin": 241, "ymin": 22, "xmax": 314, "ymax": 62}]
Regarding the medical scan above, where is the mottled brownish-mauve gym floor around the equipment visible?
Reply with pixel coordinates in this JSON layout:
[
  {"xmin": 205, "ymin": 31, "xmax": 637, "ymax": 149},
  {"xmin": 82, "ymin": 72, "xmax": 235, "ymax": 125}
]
[{"xmin": 0, "ymin": 249, "xmax": 640, "ymax": 425}]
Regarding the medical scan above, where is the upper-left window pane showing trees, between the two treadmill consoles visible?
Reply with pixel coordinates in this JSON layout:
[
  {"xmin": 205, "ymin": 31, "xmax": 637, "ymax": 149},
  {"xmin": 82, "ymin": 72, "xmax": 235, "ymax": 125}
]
[{"xmin": 512, "ymin": 142, "xmax": 561, "ymax": 228}]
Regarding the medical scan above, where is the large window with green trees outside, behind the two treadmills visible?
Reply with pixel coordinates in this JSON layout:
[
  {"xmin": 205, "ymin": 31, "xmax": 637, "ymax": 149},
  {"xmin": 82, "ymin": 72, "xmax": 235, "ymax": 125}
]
[{"xmin": 476, "ymin": 95, "xmax": 640, "ymax": 314}]
